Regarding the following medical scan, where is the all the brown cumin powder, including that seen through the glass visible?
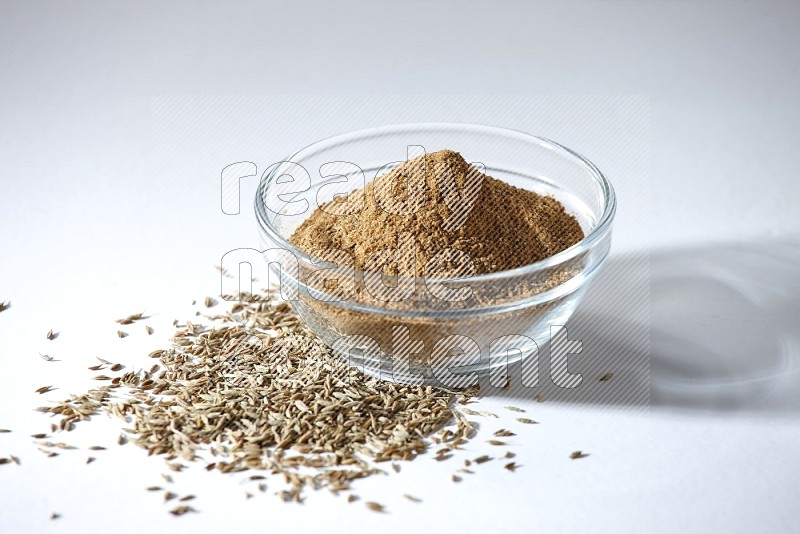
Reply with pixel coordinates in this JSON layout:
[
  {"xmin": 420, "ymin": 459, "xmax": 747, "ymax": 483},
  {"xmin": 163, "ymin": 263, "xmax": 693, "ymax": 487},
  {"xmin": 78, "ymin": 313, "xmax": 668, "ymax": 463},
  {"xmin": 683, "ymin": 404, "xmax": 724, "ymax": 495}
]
[{"xmin": 289, "ymin": 150, "xmax": 584, "ymax": 381}]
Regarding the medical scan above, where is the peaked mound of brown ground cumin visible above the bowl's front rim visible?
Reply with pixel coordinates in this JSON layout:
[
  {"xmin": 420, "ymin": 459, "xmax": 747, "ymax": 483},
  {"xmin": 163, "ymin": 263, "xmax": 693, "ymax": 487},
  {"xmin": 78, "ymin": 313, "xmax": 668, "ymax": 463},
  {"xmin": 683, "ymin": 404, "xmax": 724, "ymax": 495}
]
[{"xmin": 290, "ymin": 150, "xmax": 584, "ymax": 277}]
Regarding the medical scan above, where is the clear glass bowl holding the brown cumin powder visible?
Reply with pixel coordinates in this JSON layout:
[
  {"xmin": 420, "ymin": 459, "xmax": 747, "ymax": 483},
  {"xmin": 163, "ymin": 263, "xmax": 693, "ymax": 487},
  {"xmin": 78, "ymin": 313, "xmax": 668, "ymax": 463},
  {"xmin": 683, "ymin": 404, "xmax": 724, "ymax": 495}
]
[{"xmin": 255, "ymin": 123, "xmax": 616, "ymax": 386}]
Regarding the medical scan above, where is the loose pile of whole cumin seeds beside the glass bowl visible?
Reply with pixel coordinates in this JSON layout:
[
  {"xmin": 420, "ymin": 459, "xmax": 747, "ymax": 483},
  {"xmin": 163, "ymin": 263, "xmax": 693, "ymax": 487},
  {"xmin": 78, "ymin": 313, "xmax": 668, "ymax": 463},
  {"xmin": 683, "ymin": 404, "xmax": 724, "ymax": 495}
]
[{"xmin": 39, "ymin": 294, "xmax": 476, "ymax": 501}]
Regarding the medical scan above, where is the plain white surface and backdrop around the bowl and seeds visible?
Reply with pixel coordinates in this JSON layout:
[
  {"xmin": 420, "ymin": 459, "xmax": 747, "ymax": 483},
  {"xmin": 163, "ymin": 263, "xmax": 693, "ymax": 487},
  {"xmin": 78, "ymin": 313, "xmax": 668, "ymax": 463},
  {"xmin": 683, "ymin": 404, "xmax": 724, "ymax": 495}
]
[{"xmin": 0, "ymin": 2, "xmax": 800, "ymax": 532}]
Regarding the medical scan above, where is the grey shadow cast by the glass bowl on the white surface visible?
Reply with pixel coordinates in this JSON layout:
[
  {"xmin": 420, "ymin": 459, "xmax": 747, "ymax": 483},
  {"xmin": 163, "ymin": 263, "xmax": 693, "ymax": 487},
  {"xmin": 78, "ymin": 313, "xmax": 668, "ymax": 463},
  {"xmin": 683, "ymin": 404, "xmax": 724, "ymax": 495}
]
[{"xmin": 482, "ymin": 241, "xmax": 800, "ymax": 414}]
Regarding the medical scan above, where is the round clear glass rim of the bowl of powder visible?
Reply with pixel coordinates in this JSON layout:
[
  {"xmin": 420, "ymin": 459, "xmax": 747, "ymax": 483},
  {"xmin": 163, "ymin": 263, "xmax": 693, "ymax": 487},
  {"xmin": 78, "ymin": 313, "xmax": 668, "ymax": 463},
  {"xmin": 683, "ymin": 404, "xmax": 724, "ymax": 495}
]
[{"xmin": 255, "ymin": 122, "xmax": 617, "ymax": 286}]
